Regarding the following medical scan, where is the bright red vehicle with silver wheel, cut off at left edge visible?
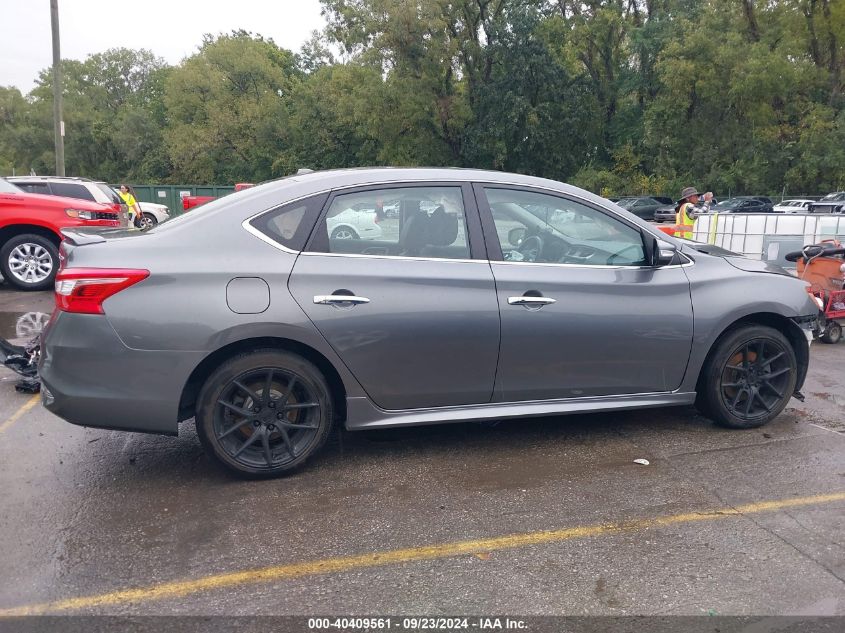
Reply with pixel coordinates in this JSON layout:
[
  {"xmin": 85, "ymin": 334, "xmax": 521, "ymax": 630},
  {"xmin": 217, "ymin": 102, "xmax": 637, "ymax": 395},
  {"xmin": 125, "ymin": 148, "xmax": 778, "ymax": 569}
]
[{"xmin": 0, "ymin": 178, "xmax": 121, "ymax": 290}]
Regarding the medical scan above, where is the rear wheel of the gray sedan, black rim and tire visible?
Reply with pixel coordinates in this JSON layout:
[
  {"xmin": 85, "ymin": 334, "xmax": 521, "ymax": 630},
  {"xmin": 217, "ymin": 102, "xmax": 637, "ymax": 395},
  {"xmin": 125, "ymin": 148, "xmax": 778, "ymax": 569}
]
[{"xmin": 196, "ymin": 349, "xmax": 333, "ymax": 479}]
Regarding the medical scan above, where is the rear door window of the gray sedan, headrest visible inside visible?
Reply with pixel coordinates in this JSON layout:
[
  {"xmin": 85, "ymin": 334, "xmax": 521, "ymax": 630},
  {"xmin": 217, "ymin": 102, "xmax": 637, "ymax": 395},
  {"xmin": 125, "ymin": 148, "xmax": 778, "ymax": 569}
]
[{"xmin": 311, "ymin": 186, "xmax": 470, "ymax": 259}]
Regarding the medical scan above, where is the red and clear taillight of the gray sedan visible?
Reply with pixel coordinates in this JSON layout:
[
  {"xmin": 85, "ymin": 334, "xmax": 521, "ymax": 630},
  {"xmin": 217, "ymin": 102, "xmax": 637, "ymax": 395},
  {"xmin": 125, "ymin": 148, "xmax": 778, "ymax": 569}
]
[{"xmin": 56, "ymin": 268, "xmax": 150, "ymax": 314}]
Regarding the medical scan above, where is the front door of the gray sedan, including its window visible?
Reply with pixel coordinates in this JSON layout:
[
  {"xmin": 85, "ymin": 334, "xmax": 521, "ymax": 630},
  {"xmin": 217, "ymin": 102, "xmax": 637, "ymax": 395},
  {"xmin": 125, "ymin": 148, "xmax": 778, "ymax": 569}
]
[{"xmin": 475, "ymin": 185, "xmax": 693, "ymax": 402}]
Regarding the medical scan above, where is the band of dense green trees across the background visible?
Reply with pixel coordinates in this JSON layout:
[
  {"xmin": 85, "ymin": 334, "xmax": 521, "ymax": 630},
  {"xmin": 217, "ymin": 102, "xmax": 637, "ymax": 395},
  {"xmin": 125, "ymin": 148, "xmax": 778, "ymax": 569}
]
[{"xmin": 0, "ymin": 0, "xmax": 845, "ymax": 196}]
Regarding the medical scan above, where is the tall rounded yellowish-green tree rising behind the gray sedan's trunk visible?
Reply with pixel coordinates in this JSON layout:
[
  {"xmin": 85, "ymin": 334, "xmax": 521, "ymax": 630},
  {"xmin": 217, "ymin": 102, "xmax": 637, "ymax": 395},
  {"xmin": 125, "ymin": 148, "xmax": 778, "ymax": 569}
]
[{"xmin": 164, "ymin": 31, "xmax": 301, "ymax": 183}]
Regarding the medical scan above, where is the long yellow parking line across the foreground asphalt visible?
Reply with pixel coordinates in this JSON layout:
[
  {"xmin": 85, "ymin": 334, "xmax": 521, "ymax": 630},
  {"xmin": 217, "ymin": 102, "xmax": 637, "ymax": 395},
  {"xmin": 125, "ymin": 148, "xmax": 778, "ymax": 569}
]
[{"xmin": 0, "ymin": 492, "xmax": 845, "ymax": 617}]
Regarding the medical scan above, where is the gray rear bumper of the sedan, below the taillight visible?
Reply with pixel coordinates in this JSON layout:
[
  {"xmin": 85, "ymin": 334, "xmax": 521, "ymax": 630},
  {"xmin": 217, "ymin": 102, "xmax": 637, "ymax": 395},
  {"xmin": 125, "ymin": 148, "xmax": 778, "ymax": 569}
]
[{"xmin": 39, "ymin": 312, "xmax": 204, "ymax": 435}]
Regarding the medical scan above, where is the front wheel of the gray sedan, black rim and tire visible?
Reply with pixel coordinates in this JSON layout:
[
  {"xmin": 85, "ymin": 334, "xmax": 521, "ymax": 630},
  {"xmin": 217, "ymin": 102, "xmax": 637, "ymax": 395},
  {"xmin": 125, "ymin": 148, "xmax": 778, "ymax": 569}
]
[{"xmin": 696, "ymin": 325, "xmax": 798, "ymax": 429}]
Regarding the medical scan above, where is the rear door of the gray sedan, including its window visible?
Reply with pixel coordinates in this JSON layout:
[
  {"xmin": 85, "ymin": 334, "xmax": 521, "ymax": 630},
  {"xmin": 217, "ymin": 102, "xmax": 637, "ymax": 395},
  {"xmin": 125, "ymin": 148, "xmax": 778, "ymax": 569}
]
[{"xmin": 289, "ymin": 183, "xmax": 499, "ymax": 410}]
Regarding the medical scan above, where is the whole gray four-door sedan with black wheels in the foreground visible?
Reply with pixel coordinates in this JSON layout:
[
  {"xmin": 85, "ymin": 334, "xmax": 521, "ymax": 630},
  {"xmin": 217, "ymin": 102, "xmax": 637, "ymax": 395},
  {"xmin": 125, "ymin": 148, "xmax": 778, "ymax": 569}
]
[{"xmin": 39, "ymin": 168, "xmax": 818, "ymax": 477}]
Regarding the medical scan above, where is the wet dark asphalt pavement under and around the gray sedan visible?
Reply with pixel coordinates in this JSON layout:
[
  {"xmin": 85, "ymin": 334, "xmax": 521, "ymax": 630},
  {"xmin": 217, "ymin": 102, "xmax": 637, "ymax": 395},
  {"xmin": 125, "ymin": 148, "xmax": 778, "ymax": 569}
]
[{"xmin": 0, "ymin": 285, "xmax": 845, "ymax": 615}]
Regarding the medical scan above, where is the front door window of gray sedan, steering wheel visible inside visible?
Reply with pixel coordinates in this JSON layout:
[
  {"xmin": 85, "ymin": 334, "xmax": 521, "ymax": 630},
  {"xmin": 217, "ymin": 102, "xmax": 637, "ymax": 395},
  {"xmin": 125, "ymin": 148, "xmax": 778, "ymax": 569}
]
[{"xmin": 484, "ymin": 188, "xmax": 645, "ymax": 266}]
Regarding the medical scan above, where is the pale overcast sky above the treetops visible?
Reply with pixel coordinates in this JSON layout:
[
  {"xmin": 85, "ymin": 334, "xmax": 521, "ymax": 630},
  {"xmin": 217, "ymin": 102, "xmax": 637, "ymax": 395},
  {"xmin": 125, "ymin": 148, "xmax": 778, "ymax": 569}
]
[{"xmin": 0, "ymin": 0, "xmax": 325, "ymax": 93}]
